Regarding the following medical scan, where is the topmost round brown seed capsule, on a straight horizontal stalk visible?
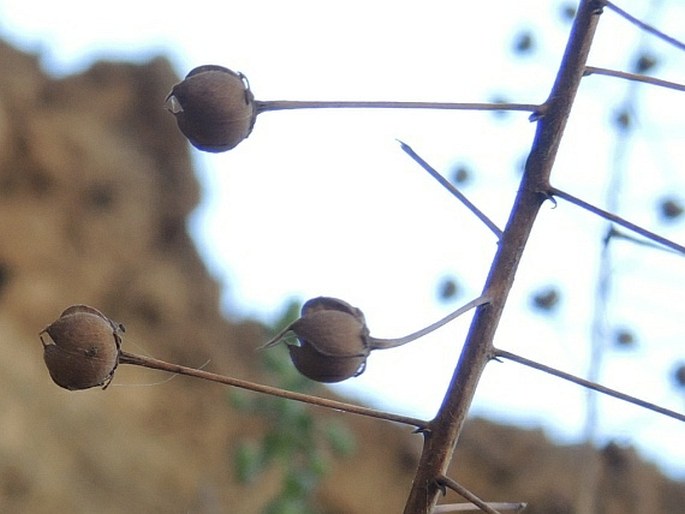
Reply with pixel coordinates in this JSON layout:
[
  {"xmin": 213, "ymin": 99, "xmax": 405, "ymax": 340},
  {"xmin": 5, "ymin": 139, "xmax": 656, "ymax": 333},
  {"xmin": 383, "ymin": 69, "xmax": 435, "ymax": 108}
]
[{"xmin": 166, "ymin": 64, "xmax": 257, "ymax": 152}]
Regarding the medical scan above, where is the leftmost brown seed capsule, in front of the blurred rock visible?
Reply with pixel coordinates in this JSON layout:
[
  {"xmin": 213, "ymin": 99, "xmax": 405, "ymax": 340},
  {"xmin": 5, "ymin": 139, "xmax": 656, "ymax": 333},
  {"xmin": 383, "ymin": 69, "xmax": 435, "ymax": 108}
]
[{"xmin": 40, "ymin": 305, "xmax": 123, "ymax": 390}]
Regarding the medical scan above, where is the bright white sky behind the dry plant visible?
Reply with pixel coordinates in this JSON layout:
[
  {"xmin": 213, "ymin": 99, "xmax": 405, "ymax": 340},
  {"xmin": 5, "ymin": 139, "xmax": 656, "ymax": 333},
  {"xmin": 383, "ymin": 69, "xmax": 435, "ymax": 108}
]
[{"xmin": 0, "ymin": 0, "xmax": 685, "ymax": 478}]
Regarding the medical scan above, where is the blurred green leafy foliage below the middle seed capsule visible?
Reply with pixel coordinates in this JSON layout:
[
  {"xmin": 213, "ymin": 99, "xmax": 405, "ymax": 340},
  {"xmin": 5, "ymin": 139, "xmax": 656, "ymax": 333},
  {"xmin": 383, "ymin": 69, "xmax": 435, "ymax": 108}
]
[{"xmin": 230, "ymin": 302, "xmax": 356, "ymax": 514}]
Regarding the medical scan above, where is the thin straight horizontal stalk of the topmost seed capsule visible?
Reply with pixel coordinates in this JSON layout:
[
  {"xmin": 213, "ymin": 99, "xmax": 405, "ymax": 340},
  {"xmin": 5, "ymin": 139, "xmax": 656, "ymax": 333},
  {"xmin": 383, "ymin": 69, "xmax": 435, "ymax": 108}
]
[{"xmin": 255, "ymin": 100, "xmax": 541, "ymax": 113}]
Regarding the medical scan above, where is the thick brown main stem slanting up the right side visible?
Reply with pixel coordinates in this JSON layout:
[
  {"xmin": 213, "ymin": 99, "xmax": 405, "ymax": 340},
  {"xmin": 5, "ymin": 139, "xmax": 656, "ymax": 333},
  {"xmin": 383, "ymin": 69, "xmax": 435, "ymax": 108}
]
[{"xmin": 404, "ymin": 0, "xmax": 599, "ymax": 514}]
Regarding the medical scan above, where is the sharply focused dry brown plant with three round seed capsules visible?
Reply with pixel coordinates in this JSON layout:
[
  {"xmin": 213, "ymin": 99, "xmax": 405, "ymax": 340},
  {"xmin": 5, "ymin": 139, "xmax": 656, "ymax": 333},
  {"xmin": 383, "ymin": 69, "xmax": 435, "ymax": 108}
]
[{"xmin": 41, "ymin": 0, "xmax": 685, "ymax": 514}]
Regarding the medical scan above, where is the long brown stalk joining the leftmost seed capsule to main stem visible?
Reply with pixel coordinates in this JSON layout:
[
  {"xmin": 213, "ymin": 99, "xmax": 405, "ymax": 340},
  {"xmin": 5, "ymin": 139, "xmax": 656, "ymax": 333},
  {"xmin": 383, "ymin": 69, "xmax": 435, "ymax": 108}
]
[{"xmin": 119, "ymin": 351, "xmax": 428, "ymax": 431}]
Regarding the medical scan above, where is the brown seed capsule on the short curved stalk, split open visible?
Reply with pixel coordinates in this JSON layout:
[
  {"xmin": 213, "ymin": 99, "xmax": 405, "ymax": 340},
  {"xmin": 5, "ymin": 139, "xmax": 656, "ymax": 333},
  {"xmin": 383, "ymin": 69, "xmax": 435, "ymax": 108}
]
[{"xmin": 288, "ymin": 297, "xmax": 370, "ymax": 382}]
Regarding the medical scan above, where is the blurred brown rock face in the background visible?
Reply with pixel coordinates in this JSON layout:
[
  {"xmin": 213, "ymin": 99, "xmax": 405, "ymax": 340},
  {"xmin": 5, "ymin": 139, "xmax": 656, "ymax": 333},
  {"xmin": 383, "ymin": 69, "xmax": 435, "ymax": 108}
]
[{"xmin": 0, "ymin": 44, "xmax": 685, "ymax": 514}]
